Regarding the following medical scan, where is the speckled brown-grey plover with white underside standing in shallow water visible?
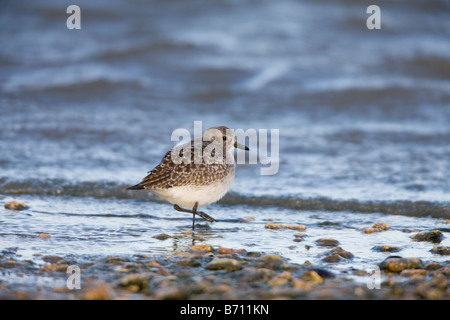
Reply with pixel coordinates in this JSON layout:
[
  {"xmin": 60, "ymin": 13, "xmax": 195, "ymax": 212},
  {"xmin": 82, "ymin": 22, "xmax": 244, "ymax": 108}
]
[{"xmin": 128, "ymin": 126, "xmax": 249, "ymax": 230}]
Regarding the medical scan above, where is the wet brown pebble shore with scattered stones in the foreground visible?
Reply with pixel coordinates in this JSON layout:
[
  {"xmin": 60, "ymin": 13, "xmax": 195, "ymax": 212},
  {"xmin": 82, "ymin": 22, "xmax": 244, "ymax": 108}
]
[{"xmin": 0, "ymin": 204, "xmax": 450, "ymax": 300}]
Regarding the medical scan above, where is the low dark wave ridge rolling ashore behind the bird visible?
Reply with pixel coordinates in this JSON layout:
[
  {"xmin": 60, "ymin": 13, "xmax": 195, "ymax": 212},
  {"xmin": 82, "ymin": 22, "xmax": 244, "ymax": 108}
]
[{"xmin": 0, "ymin": 178, "xmax": 450, "ymax": 219}]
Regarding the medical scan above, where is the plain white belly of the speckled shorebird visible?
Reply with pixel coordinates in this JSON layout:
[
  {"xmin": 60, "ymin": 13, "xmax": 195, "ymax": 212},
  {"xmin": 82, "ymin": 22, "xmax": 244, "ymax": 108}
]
[{"xmin": 148, "ymin": 173, "xmax": 234, "ymax": 209}]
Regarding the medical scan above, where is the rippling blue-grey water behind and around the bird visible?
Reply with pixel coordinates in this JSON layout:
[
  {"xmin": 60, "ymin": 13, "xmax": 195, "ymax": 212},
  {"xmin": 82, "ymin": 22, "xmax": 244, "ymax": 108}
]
[{"xmin": 0, "ymin": 0, "xmax": 450, "ymax": 280}]
